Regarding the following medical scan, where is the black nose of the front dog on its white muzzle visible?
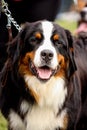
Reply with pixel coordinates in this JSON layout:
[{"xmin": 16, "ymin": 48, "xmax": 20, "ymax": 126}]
[{"xmin": 41, "ymin": 49, "xmax": 53, "ymax": 62}]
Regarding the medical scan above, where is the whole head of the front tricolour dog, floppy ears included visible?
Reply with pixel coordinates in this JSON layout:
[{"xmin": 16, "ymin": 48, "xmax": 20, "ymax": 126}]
[{"xmin": 8, "ymin": 21, "xmax": 76, "ymax": 81}]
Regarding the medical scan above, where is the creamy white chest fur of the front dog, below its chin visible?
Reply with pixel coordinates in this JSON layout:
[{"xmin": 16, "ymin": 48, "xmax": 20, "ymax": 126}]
[{"xmin": 25, "ymin": 76, "xmax": 67, "ymax": 130}]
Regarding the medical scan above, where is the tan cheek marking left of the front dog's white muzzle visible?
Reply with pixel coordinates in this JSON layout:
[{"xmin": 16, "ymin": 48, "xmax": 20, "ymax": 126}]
[{"xmin": 19, "ymin": 52, "xmax": 34, "ymax": 76}]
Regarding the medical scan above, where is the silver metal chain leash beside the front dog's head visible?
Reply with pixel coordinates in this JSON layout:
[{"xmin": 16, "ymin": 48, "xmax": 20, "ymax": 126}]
[{"xmin": 2, "ymin": 0, "xmax": 22, "ymax": 32}]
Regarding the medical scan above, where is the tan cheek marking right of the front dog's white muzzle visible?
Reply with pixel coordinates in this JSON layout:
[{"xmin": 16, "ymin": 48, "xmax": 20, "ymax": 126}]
[{"xmin": 55, "ymin": 54, "xmax": 67, "ymax": 77}]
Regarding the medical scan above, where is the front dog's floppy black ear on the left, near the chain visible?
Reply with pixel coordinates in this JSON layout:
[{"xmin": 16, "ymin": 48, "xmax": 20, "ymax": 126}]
[{"xmin": 7, "ymin": 22, "xmax": 30, "ymax": 62}]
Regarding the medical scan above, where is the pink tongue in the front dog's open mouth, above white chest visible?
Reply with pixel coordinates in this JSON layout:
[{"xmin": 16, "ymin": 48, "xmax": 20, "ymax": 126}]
[{"xmin": 37, "ymin": 68, "xmax": 52, "ymax": 79}]
